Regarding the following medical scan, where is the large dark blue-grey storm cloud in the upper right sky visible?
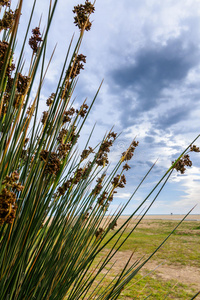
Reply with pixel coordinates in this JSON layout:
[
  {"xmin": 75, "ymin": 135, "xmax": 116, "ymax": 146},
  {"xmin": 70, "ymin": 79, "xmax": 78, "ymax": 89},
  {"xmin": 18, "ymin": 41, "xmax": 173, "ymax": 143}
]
[{"xmin": 111, "ymin": 39, "xmax": 199, "ymax": 98}]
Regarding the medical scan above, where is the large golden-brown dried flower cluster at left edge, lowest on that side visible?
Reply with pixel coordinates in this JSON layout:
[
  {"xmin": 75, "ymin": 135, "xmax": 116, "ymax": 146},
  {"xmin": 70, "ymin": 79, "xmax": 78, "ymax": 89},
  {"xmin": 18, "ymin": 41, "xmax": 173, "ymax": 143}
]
[{"xmin": 0, "ymin": 171, "xmax": 23, "ymax": 225}]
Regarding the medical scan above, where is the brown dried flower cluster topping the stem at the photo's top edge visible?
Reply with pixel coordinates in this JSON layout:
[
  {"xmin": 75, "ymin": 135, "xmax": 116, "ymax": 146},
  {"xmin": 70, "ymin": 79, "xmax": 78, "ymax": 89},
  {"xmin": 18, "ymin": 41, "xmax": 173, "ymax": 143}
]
[{"xmin": 73, "ymin": 0, "xmax": 95, "ymax": 31}]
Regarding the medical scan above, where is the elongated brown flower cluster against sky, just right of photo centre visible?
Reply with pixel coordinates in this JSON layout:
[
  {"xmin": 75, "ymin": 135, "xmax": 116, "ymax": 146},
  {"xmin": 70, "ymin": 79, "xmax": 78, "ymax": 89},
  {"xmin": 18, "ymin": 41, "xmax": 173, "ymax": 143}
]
[{"xmin": 96, "ymin": 132, "xmax": 117, "ymax": 166}]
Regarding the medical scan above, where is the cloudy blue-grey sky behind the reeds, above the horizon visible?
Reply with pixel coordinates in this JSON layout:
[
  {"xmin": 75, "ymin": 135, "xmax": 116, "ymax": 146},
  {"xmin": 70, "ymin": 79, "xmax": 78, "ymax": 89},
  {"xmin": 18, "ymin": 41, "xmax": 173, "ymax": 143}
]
[{"xmin": 11, "ymin": 0, "xmax": 200, "ymax": 214}]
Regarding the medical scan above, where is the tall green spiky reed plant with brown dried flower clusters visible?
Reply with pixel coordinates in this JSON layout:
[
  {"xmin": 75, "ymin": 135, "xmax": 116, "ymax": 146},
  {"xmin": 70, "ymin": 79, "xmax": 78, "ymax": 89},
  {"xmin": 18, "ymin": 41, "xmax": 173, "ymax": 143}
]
[{"xmin": 0, "ymin": 0, "xmax": 199, "ymax": 300}]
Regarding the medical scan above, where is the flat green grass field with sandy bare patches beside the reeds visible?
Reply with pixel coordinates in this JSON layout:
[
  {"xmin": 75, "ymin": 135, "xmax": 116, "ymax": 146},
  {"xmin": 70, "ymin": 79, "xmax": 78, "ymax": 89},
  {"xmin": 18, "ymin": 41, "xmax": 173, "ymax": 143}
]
[{"xmin": 94, "ymin": 217, "xmax": 200, "ymax": 300}]
